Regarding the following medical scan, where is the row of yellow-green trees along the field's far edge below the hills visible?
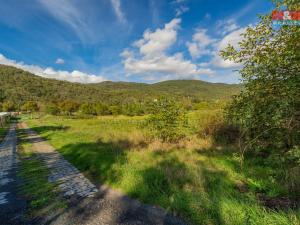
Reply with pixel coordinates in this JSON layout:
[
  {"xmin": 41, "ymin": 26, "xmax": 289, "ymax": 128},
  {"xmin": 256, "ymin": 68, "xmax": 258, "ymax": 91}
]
[{"xmin": 0, "ymin": 98, "xmax": 226, "ymax": 116}]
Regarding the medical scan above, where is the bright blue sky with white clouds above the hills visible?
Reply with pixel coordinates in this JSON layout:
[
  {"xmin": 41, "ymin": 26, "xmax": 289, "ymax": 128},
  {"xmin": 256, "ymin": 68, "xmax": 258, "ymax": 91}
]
[{"xmin": 0, "ymin": 0, "xmax": 272, "ymax": 83}]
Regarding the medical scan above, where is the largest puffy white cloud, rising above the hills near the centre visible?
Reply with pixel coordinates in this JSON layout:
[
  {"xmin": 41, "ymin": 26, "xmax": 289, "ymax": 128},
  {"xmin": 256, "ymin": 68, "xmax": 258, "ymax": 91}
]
[{"xmin": 121, "ymin": 18, "xmax": 214, "ymax": 80}]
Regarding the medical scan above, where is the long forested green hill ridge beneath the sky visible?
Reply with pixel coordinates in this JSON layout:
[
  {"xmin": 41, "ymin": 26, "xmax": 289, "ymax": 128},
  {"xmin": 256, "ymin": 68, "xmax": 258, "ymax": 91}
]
[{"xmin": 0, "ymin": 65, "xmax": 241, "ymax": 104}]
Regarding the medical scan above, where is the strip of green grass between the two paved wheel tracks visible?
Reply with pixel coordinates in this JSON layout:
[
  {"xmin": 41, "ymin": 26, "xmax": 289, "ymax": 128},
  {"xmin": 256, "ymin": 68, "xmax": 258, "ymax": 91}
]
[{"xmin": 18, "ymin": 131, "xmax": 67, "ymax": 218}]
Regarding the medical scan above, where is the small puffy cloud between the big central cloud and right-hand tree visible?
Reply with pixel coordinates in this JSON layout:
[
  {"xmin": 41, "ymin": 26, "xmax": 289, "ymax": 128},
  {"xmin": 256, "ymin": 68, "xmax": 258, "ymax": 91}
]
[{"xmin": 186, "ymin": 29, "xmax": 216, "ymax": 58}]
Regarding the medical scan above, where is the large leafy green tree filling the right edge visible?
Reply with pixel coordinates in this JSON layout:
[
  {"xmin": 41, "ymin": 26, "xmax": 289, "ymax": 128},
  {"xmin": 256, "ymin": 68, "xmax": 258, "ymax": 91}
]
[{"xmin": 221, "ymin": 0, "xmax": 300, "ymax": 192}]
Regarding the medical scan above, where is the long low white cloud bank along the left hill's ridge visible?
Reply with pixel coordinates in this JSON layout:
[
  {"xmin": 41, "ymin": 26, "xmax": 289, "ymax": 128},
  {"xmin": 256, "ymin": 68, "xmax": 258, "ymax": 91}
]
[{"xmin": 0, "ymin": 54, "xmax": 106, "ymax": 83}]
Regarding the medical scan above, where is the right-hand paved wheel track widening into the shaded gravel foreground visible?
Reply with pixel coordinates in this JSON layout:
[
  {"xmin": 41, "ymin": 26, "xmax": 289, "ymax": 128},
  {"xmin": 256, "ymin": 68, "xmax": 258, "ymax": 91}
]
[{"xmin": 16, "ymin": 123, "xmax": 185, "ymax": 225}]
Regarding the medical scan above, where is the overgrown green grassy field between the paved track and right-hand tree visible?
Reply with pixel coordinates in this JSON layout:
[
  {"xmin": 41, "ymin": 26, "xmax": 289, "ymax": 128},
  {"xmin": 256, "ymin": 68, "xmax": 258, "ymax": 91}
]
[{"xmin": 23, "ymin": 110, "xmax": 300, "ymax": 225}]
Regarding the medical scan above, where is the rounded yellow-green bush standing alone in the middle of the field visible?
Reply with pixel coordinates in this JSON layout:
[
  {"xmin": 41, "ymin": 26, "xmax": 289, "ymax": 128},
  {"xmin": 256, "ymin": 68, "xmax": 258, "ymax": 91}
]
[{"xmin": 147, "ymin": 98, "xmax": 187, "ymax": 142}]
